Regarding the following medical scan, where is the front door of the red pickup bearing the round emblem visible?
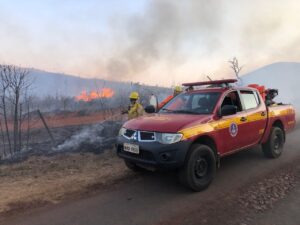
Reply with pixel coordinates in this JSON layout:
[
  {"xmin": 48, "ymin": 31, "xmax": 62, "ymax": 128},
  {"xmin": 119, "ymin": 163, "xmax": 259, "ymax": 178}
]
[{"xmin": 217, "ymin": 91, "xmax": 248, "ymax": 154}]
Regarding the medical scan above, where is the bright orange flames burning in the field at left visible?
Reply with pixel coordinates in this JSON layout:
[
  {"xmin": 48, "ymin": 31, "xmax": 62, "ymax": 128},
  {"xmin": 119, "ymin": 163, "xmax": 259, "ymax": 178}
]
[{"xmin": 75, "ymin": 88, "xmax": 115, "ymax": 102}]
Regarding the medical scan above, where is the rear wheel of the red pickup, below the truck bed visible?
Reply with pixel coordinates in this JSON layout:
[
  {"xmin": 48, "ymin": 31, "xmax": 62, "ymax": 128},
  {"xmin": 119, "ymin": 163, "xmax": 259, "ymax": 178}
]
[{"xmin": 262, "ymin": 127, "xmax": 284, "ymax": 159}]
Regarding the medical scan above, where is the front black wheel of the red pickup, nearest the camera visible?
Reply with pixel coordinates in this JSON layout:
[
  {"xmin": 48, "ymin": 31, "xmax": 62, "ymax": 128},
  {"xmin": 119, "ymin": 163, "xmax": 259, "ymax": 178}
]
[{"xmin": 179, "ymin": 144, "xmax": 216, "ymax": 191}]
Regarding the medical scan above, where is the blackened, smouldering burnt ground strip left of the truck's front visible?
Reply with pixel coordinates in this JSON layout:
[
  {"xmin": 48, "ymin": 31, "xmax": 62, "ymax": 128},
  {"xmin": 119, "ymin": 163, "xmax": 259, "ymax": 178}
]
[{"xmin": 0, "ymin": 120, "xmax": 122, "ymax": 164}]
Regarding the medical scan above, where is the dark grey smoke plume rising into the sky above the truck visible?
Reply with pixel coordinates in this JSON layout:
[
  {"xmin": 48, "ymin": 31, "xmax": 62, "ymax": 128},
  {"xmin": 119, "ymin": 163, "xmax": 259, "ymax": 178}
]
[{"xmin": 107, "ymin": 0, "xmax": 222, "ymax": 78}]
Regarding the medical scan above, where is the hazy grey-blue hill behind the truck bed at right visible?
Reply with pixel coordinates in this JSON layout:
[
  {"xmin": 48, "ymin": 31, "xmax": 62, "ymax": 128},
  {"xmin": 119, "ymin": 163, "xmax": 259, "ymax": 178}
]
[{"xmin": 242, "ymin": 62, "xmax": 300, "ymax": 109}]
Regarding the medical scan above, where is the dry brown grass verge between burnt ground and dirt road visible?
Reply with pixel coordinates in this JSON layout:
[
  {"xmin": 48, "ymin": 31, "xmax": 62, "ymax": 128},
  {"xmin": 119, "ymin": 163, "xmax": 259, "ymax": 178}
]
[{"xmin": 0, "ymin": 151, "xmax": 131, "ymax": 213}]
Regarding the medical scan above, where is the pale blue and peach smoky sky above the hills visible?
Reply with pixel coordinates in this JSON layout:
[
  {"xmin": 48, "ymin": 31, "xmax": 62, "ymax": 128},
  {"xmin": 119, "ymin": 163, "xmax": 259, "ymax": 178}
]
[{"xmin": 0, "ymin": 0, "xmax": 300, "ymax": 86}]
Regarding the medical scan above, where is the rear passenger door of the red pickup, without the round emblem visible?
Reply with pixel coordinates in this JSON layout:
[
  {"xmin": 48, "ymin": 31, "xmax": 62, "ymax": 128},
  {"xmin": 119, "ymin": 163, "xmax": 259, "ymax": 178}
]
[{"xmin": 240, "ymin": 90, "xmax": 267, "ymax": 146}]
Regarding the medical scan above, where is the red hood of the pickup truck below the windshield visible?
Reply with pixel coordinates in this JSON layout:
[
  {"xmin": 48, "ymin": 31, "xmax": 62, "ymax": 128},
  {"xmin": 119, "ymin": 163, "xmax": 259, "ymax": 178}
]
[{"xmin": 124, "ymin": 113, "xmax": 212, "ymax": 133}]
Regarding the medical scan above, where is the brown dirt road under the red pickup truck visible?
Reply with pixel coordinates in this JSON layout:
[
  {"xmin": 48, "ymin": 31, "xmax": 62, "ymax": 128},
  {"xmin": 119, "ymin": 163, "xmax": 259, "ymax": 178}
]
[{"xmin": 0, "ymin": 130, "xmax": 300, "ymax": 225}]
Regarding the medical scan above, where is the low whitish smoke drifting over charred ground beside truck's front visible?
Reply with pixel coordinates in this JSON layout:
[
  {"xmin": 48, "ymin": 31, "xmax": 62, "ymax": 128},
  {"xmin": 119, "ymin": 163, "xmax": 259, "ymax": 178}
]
[{"xmin": 53, "ymin": 121, "xmax": 122, "ymax": 152}]
